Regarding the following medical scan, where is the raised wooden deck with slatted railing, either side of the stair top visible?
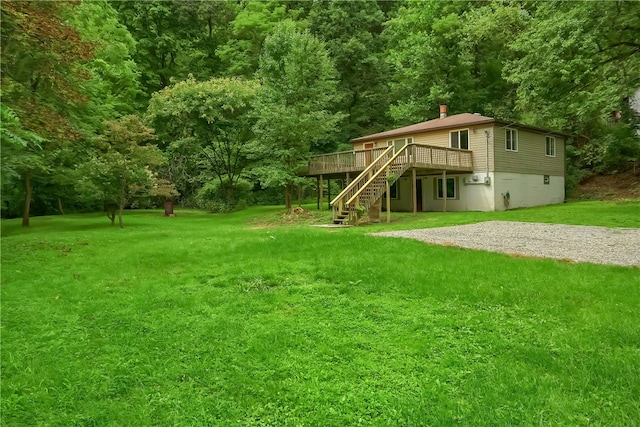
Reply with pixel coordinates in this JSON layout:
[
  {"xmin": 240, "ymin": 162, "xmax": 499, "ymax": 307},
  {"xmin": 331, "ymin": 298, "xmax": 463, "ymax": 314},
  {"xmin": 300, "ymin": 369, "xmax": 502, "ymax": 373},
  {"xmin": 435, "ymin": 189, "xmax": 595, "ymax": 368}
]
[{"xmin": 306, "ymin": 144, "xmax": 473, "ymax": 176}]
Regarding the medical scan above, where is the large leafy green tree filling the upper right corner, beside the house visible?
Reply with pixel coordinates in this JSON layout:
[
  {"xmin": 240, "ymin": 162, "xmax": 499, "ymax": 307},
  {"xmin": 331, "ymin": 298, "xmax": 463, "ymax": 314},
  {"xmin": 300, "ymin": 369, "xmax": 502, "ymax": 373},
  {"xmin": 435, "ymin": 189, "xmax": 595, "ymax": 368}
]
[{"xmin": 507, "ymin": 1, "xmax": 640, "ymax": 172}]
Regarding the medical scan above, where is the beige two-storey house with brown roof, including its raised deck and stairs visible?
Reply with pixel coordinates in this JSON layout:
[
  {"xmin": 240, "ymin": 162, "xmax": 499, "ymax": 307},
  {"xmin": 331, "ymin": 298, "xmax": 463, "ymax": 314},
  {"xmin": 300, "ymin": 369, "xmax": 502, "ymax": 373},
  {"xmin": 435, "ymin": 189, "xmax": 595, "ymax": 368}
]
[{"xmin": 307, "ymin": 106, "xmax": 567, "ymax": 223}]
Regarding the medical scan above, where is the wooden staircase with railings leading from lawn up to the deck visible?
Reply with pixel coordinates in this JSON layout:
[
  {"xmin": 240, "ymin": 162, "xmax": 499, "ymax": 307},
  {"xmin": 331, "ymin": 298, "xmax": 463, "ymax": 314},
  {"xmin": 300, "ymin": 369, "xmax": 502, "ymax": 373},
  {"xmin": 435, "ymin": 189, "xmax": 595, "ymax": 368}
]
[{"xmin": 331, "ymin": 145, "xmax": 412, "ymax": 225}]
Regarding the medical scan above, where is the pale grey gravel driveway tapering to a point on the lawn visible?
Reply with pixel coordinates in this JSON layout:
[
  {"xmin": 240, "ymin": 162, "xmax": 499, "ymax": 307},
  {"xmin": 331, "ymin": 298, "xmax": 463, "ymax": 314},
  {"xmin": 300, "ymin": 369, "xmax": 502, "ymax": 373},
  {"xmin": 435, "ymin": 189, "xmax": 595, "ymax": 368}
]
[{"xmin": 373, "ymin": 221, "xmax": 640, "ymax": 267}]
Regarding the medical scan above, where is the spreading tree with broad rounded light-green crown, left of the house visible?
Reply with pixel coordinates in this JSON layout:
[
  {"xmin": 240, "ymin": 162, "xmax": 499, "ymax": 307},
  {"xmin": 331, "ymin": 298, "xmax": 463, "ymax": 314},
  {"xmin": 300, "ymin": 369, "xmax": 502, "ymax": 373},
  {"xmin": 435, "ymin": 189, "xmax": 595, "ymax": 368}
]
[{"xmin": 148, "ymin": 78, "xmax": 257, "ymax": 210}]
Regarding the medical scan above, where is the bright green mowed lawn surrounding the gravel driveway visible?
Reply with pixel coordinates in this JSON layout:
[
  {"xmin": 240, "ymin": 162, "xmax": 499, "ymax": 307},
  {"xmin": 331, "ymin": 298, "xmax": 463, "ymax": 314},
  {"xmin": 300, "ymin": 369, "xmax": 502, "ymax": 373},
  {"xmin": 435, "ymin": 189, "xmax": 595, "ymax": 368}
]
[{"xmin": 1, "ymin": 202, "xmax": 640, "ymax": 426}]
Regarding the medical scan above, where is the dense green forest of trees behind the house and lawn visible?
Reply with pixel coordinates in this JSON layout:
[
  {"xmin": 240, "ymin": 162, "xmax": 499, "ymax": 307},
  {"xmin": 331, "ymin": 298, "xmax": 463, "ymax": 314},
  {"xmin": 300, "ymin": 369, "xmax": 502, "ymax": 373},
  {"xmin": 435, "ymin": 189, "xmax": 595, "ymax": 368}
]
[{"xmin": 1, "ymin": 0, "xmax": 640, "ymax": 225}]
